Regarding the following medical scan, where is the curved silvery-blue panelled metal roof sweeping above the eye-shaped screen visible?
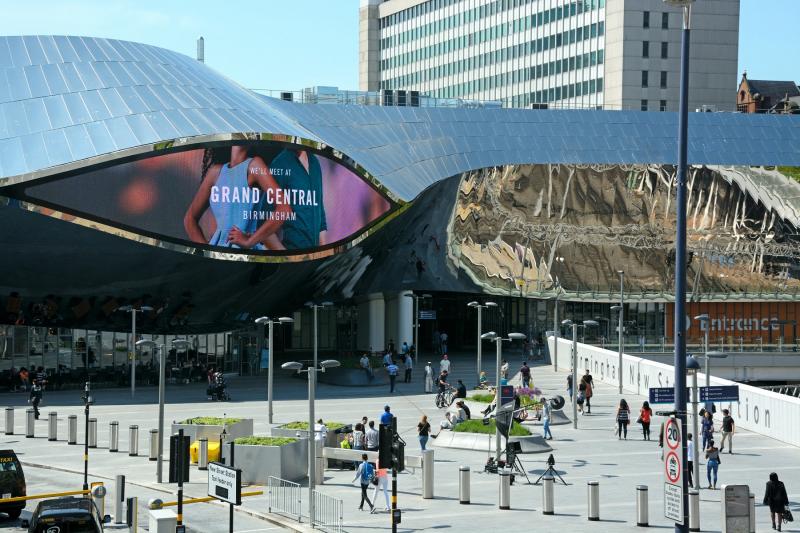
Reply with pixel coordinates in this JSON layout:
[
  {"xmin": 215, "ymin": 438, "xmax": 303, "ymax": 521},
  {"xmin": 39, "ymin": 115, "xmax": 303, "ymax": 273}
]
[{"xmin": 0, "ymin": 36, "xmax": 800, "ymax": 200}]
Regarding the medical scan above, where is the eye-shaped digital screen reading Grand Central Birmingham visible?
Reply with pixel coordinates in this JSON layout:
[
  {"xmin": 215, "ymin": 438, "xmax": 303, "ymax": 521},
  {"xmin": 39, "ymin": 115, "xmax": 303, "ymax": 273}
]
[{"xmin": 17, "ymin": 143, "xmax": 392, "ymax": 254}]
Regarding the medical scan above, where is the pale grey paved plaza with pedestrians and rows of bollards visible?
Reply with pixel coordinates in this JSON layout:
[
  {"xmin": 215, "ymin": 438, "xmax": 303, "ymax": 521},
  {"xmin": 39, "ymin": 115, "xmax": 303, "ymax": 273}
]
[{"xmin": 0, "ymin": 356, "xmax": 800, "ymax": 533}]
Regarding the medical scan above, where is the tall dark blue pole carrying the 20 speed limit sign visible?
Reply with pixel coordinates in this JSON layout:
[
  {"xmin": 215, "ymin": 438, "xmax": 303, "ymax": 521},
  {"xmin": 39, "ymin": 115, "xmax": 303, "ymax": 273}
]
[{"xmin": 673, "ymin": 5, "xmax": 691, "ymax": 533}]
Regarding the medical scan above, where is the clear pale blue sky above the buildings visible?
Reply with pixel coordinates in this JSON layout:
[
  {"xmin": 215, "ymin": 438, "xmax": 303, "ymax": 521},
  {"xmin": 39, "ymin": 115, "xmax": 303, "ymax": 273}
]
[{"xmin": 0, "ymin": 0, "xmax": 800, "ymax": 90}]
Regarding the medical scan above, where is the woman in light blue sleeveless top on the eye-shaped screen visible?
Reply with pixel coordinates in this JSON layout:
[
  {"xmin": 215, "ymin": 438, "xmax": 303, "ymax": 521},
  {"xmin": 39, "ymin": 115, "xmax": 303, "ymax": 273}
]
[{"xmin": 183, "ymin": 146, "xmax": 292, "ymax": 250}]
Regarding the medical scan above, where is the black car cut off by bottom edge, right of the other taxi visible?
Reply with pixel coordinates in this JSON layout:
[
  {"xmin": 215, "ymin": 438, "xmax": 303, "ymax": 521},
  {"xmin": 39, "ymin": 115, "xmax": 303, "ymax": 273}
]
[{"xmin": 22, "ymin": 497, "xmax": 111, "ymax": 533}]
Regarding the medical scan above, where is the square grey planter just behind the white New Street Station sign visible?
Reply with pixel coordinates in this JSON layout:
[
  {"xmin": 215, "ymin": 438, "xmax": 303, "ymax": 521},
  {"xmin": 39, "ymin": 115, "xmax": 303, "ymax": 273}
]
[{"xmin": 222, "ymin": 439, "xmax": 308, "ymax": 485}]
